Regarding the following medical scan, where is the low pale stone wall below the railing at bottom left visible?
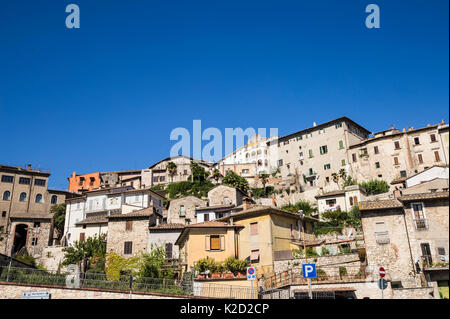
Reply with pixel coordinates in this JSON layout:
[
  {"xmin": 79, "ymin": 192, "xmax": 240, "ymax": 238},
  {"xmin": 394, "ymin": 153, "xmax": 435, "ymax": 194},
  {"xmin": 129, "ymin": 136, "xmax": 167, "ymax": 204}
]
[{"xmin": 0, "ymin": 282, "xmax": 192, "ymax": 299}]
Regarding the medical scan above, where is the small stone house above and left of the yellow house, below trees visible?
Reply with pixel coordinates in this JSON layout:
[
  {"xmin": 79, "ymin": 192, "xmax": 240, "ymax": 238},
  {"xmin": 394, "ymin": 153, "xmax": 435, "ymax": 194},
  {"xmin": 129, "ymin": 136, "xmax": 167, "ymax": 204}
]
[{"xmin": 167, "ymin": 195, "xmax": 206, "ymax": 225}]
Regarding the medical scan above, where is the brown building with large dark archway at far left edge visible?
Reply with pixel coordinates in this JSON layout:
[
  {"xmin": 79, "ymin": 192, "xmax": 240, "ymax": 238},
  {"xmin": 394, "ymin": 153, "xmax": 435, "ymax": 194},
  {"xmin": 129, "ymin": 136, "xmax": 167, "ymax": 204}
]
[{"xmin": 0, "ymin": 165, "xmax": 73, "ymax": 255}]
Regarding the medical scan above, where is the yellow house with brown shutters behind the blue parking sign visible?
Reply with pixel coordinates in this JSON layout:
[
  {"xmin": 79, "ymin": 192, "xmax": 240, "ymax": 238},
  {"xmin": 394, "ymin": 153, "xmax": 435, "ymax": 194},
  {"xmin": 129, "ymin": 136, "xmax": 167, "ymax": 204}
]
[{"xmin": 175, "ymin": 205, "xmax": 316, "ymax": 276}]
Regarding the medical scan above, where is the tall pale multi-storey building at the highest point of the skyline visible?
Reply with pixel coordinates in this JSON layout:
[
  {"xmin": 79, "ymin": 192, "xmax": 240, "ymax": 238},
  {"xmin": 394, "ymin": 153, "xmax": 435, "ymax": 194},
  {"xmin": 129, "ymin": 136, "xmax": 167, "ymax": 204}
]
[{"xmin": 268, "ymin": 117, "xmax": 370, "ymax": 197}]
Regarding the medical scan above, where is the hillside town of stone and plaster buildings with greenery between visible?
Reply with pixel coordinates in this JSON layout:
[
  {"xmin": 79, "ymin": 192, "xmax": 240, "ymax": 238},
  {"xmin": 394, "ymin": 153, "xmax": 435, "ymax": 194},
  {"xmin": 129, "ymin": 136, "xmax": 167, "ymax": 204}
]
[{"xmin": 0, "ymin": 117, "xmax": 449, "ymax": 299}]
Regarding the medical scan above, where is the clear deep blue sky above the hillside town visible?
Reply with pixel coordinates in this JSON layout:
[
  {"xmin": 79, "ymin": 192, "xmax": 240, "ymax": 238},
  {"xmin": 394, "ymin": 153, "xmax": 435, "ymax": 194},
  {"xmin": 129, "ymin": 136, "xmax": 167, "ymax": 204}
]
[{"xmin": 0, "ymin": 0, "xmax": 449, "ymax": 189}]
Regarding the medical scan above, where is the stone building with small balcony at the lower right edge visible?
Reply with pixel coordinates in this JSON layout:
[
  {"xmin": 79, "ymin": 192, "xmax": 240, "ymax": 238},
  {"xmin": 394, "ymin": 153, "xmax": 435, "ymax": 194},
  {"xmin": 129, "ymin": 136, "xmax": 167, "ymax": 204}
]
[{"xmin": 359, "ymin": 190, "xmax": 449, "ymax": 296}]
